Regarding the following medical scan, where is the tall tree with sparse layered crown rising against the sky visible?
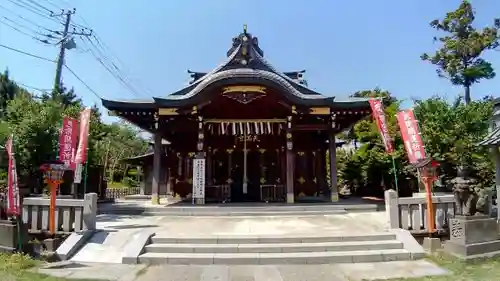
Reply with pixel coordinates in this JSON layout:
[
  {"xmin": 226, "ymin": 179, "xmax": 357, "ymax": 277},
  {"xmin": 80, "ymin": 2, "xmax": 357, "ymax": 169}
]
[{"xmin": 421, "ymin": 0, "xmax": 500, "ymax": 104}]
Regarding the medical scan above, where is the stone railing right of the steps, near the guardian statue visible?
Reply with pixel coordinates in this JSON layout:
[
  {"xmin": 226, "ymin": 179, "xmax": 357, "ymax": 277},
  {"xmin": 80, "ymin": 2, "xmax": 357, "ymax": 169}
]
[{"xmin": 385, "ymin": 190, "xmax": 455, "ymax": 234}]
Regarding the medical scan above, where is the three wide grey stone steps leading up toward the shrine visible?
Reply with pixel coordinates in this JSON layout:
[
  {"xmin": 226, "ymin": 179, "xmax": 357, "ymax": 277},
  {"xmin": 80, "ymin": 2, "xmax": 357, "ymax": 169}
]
[{"xmin": 138, "ymin": 233, "xmax": 421, "ymax": 265}]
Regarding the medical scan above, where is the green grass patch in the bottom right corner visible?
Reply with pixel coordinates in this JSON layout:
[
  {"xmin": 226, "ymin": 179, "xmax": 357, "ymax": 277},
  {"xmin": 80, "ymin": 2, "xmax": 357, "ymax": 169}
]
[{"xmin": 391, "ymin": 254, "xmax": 500, "ymax": 281}]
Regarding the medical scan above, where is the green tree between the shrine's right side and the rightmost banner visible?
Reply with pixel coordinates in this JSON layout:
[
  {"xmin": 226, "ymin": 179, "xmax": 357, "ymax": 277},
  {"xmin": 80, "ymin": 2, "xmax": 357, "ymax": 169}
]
[{"xmin": 337, "ymin": 89, "xmax": 413, "ymax": 196}]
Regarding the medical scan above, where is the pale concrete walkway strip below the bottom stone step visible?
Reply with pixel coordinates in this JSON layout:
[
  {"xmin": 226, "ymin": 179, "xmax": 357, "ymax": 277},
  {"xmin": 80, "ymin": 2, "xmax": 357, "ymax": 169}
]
[{"xmin": 38, "ymin": 260, "xmax": 447, "ymax": 281}]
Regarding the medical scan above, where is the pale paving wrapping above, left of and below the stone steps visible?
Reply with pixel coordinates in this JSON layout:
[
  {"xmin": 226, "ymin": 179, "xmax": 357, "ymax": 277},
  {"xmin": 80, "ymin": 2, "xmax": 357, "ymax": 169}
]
[{"xmin": 50, "ymin": 208, "xmax": 447, "ymax": 281}]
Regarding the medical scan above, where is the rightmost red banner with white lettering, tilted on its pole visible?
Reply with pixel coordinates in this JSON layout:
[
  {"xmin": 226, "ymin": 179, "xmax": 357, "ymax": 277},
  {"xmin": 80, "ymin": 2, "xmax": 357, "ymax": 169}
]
[{"xmin": 396, "ymin": 109, "xmax": 425, "ymax": 164}]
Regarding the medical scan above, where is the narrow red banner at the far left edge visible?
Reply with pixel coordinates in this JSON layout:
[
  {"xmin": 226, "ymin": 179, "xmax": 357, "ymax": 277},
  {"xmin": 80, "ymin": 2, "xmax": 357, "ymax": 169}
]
[{"xmin": 5, "ymin": 135, "xmax": 21, "ymax": 216}]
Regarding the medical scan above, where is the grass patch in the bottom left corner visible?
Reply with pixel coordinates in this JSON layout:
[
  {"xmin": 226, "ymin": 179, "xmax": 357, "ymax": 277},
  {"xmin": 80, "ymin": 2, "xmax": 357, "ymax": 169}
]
[{"xmin": 0, "ymin": 253, "xmax": 99, "ymax": 281}]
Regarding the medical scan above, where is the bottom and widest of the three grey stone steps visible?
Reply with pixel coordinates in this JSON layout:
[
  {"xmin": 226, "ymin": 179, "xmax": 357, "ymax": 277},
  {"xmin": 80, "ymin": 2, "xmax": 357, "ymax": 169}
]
[{"xmin": 139, "ymin": 249, "xmax": 412, "ymax": 264}]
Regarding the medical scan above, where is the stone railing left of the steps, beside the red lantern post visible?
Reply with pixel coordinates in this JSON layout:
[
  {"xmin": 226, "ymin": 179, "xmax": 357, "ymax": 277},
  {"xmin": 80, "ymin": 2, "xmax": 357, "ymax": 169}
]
[{"xmin": 22, "ymin": 193, "xmax": 97, "ymax": 233}]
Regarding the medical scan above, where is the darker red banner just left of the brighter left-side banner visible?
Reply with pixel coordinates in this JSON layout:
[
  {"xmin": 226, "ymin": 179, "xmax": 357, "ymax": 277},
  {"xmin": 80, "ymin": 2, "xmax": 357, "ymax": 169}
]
[{"xmin": 59, "ymin": 117, "xmax": 78, "ymax": 170}]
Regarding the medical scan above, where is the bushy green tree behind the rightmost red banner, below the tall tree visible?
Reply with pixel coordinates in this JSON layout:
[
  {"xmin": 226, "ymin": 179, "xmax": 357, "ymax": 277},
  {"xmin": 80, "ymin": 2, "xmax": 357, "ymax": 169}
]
[{"xmin": 414, "ymin": 97, "xmax": 494, "ymax": 186}]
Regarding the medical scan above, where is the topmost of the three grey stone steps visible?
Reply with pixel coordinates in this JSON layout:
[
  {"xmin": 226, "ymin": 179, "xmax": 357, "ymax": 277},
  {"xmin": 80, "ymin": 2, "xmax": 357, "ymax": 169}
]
[{"xmin": 151, "ymin": 233, "xmax": 397, "ymax": 244}]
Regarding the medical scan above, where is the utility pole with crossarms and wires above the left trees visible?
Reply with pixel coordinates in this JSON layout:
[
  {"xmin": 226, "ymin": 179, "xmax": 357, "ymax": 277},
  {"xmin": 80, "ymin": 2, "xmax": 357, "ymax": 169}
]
[{"xmin": 51, "ymin": 9, "xmax": 92, "ymax": 92}]
